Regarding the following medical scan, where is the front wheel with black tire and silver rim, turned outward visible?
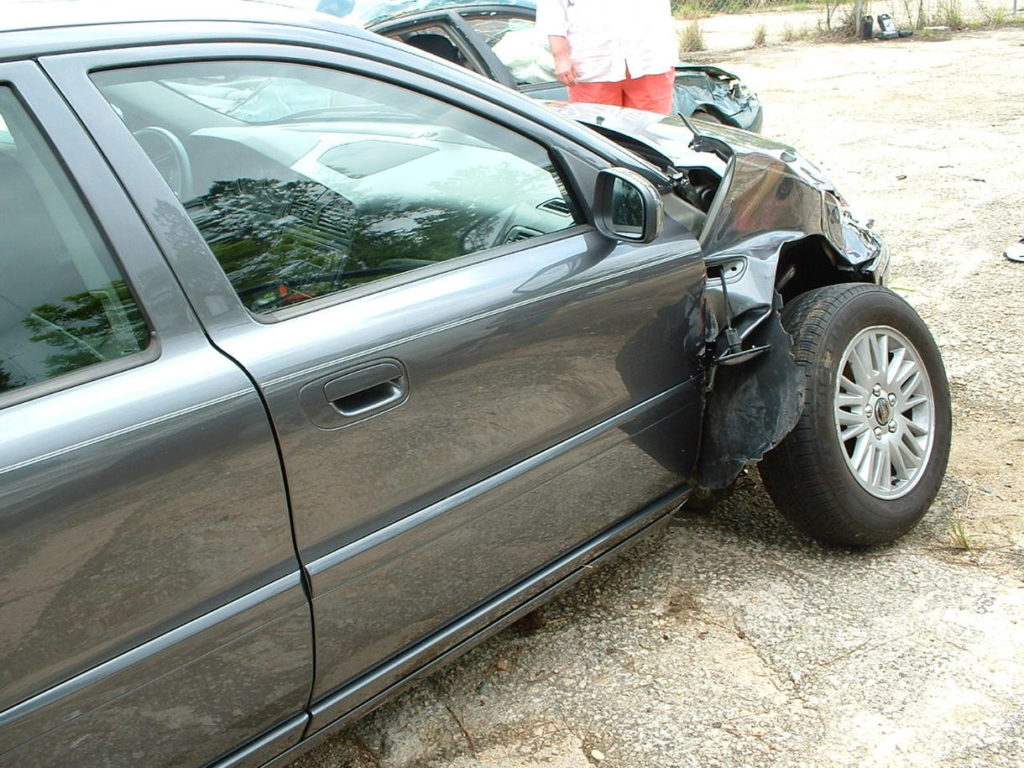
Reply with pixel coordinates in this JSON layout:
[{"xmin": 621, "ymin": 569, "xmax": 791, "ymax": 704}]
[{"xmin": 761, "ymin": 284, "xmax": 951, "ymax": 546}]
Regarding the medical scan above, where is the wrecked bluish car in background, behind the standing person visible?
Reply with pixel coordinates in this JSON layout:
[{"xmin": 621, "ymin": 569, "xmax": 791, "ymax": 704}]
[{"xmin": 276, "ymin": 0, "xmax": 764, "ymax": 131}]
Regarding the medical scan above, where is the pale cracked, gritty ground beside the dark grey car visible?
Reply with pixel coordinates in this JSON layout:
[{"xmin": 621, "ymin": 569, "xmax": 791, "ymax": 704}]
[{"xmin": 296, "ymin": 29, "xmax": 1024, "ymax": 768}]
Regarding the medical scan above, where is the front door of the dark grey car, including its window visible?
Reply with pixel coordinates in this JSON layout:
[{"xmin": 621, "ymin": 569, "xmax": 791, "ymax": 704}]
[{"xmin": 47, "ymin": 38, "xmax": 703, "ymax": 716}]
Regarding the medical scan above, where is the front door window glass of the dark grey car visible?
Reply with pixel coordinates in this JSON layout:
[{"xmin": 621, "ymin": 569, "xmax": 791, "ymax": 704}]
[{"xmin": 93, "ymin": 60, "xmax": 577, "ymax": 313}]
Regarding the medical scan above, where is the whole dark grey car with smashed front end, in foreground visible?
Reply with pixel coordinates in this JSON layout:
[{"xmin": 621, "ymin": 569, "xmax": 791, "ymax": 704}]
[{"xmin": 0, "ymin": 0, "xmax": 950, "ymax": 768}]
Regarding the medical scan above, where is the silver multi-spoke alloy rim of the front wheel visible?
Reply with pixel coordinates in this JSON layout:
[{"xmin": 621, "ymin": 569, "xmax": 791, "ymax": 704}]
[{"xmin": 833, "ymin": 326, "xmax": 935, "ymax": 499}]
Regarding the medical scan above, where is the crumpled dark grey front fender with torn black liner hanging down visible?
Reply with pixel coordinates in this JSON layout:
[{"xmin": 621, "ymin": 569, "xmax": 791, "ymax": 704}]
[{"xmin": 694, "ymin": 142, "xmax": 889, "ymax": 488}]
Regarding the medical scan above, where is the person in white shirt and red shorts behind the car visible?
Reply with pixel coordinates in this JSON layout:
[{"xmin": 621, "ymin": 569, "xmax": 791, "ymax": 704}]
[{"xmin": 537, "ymin": 0, "xmax": 679, "ymax": 115}]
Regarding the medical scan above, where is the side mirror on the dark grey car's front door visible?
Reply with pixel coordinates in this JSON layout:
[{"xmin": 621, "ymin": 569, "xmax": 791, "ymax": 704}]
[{"xmin": 594, "ymin": 168, "xmax": 665, "ymax": 243}]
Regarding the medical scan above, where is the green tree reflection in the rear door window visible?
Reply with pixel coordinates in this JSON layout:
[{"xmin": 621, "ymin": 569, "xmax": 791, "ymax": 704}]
[{"xmin": 22, "ymin": 281, "xmax": 150, "ymax": 378}]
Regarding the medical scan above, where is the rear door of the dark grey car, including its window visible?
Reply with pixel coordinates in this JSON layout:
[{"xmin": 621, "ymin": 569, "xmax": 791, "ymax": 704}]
[{"xmin": 0, "ymin": 62, "xmax": 312, "ymax": 768}]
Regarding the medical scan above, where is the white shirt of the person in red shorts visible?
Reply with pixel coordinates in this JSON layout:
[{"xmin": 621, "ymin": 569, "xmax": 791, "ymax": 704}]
[{"xmin": 537, "ymin": 0, "xmax": 679, "ymax": 83}]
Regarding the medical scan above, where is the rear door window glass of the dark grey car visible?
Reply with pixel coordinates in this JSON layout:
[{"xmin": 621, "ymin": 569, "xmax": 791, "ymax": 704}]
[{"xmin": 0, "ymin": 87, "xmax": 150, "ymax": 394}]
